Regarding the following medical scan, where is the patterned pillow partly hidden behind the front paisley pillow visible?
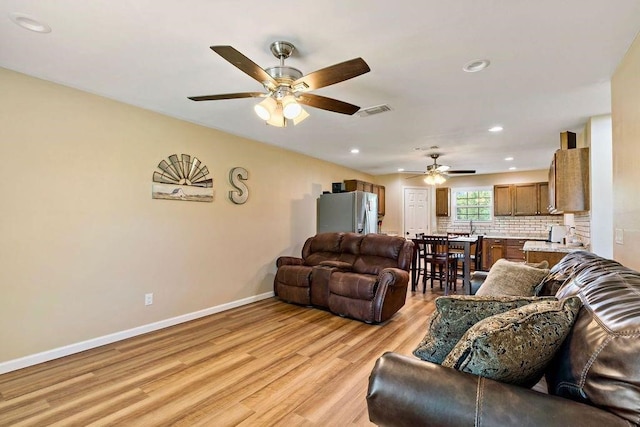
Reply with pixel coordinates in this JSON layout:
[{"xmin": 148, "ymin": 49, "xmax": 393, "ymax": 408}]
[{"xmin": 413, "ymin": 295, "xmax": 555, "ymax": 364}]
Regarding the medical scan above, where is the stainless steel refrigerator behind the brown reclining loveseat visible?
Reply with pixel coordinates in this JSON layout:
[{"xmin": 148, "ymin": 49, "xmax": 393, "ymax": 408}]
[{"xmin": 317, "ymin": 191, "xmax": 378, "ymax": 234}]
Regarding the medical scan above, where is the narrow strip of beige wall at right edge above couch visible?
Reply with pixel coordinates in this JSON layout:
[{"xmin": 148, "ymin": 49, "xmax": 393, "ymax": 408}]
[{"xmin": 611, "ymin": 33, "xmax": 640, "ymax": 270}]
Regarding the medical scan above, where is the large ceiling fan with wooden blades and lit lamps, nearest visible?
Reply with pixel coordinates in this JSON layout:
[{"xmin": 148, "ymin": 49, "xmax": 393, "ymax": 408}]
[{"xmin": 189, "ymin": 41, "xmax": 370, "ymax": 127}]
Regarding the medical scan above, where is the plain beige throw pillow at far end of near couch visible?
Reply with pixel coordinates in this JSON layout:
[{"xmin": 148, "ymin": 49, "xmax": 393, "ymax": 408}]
[{"xmin": 476, "ymin": 259, "xmax": 549, "ymax": 297}]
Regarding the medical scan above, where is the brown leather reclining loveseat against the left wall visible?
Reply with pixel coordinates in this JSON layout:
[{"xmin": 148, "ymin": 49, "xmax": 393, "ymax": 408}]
[{"xmin": 273, "ymin": 233, "xmax": 413, "ymax": 323}]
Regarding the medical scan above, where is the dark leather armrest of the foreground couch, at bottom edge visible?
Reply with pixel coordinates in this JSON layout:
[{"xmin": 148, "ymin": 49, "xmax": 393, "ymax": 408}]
[{"xmin": 367, "ymin": 353, "xmax": 629, "ymax": 427}]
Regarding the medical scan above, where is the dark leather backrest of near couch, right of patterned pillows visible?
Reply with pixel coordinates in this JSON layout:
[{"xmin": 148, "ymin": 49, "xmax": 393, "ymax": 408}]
[{"xmin": 547, "ymin": 253, "xmax": 640, "ymax": 424}]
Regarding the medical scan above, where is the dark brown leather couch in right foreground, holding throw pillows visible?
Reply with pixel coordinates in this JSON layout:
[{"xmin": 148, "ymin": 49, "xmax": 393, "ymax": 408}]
[{"xmin": 367, "ymin": 251, "xmax": 640, "ymax": 427}]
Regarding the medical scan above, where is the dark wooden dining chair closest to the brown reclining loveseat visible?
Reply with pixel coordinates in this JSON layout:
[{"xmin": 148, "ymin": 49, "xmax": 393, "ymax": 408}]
[{"xmin": 421, "ymin": 236, "xmax": 458, "ymax": 294}]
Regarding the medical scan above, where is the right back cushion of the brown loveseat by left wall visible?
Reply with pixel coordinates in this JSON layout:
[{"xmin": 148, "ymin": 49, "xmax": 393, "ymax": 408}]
[{"xmin": 353, "ymin": 234, "xmax": 412, "ymax": 275}]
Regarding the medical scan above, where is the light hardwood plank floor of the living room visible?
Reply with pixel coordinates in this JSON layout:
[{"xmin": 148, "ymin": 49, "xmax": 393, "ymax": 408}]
[{"xmin": 0, "ymin": 290, "xmax": 441, "ymax": 427}]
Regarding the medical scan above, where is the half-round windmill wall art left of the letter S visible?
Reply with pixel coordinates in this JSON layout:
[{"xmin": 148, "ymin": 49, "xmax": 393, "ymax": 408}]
[{"xmin": 151, "ymin": 154, "xmax": 213, "ymax": 202}]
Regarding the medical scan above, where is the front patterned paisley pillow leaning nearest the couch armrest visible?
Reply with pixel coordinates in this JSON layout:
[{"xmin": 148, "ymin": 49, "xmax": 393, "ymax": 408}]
[{"xmin": 442, "ymin": 297, "xmax": 582, "ymax": 387}]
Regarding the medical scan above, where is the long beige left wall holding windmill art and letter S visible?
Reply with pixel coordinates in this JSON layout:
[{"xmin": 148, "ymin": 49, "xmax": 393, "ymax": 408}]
[{"xmin": 0, "ymin": 69, "xmax": 373, "ymax": 363}]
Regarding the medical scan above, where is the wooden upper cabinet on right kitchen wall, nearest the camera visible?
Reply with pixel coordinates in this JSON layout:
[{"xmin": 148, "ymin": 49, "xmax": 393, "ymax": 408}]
[{"xmin": 549, "ymin": 147, "xmax": 591, "ymax": 213}]
